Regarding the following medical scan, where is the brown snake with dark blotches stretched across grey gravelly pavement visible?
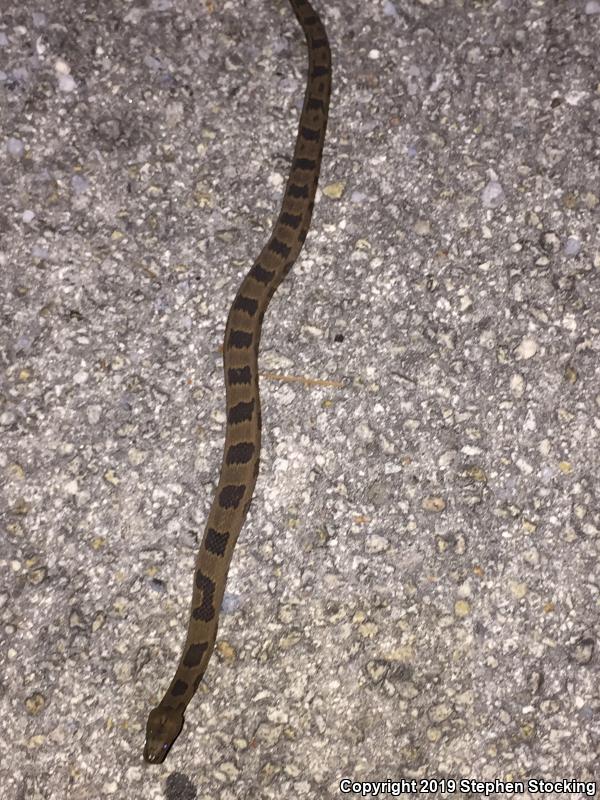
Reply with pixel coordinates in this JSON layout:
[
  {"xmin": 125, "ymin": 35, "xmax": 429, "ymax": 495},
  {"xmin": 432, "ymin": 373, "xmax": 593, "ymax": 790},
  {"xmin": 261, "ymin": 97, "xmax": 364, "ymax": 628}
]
[{"xmin": 144, "ymin": 0, "xmax": 331, "ymax": 764}]
